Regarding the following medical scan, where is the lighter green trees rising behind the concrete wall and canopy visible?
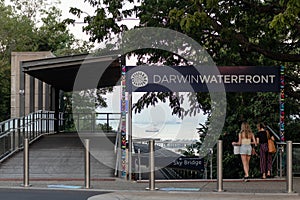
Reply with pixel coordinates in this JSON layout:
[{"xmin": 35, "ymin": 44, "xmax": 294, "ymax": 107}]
[{"xmin": 0, "ymin": 0, "xmax": 91, "ymax": 121}]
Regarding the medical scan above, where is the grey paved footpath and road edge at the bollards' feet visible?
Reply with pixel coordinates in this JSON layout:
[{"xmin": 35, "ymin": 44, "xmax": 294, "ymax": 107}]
[{"xmin": 0, "ymin": 177, "xmax": 300, "ymax": 200}]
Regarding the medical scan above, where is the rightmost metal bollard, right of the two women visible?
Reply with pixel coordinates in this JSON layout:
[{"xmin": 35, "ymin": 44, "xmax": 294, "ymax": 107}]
[{"xmin": 286, "ymin": 141, "xmax": 293, "ymax": 193}]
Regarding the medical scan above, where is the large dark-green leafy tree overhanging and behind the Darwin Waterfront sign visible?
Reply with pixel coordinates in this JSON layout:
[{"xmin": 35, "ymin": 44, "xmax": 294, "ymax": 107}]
[{"xmin": 71, "ymin": 0, "xmax": 300, "ymax": 178}]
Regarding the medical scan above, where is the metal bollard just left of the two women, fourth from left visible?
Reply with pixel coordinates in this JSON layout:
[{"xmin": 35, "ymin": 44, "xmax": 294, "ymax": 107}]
[{"xmin": 217, "ymin": 140, "xmax": 224, "ymax": 192}]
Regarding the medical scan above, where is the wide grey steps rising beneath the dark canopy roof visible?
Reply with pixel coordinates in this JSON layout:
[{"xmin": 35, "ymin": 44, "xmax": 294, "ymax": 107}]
[{"xmin": 0, "ymin": 133, "xmax": 115, "ymax": 180}]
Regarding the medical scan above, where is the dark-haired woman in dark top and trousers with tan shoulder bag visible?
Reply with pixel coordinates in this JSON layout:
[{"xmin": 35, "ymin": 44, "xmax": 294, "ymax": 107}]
[{"xmin": 256, "ymin": 123, "xmax": 272, "ymax": 179}]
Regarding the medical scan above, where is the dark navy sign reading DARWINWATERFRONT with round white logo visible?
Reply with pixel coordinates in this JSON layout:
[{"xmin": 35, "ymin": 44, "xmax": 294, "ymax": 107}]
[{"xmin": 126, "ymin": 66, "xmax": 280, "ymax": 92}]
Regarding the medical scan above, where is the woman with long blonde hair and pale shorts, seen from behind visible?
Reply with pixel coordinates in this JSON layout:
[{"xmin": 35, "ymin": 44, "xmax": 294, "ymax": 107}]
[{"xmin": 232, "ymin": 122, "xmax": 257, "ymax": 181}]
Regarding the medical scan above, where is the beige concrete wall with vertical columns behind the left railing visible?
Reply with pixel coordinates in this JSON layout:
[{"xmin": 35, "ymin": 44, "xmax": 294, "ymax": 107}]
[{"xmin": 10, "ymin": 51, "xmax": 54, "ymax": 118}]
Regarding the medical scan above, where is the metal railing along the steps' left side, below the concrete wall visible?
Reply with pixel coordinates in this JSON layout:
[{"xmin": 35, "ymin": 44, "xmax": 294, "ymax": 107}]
[{"xmin": 0, "ymin": 110, "xmax": 55, "ymax": 162}]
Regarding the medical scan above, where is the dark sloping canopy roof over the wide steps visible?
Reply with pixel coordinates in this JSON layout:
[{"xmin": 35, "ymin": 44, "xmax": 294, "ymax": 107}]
[{"xmin": 22, "ymin": 54, "xmax": 121, "ymax": 92}]
